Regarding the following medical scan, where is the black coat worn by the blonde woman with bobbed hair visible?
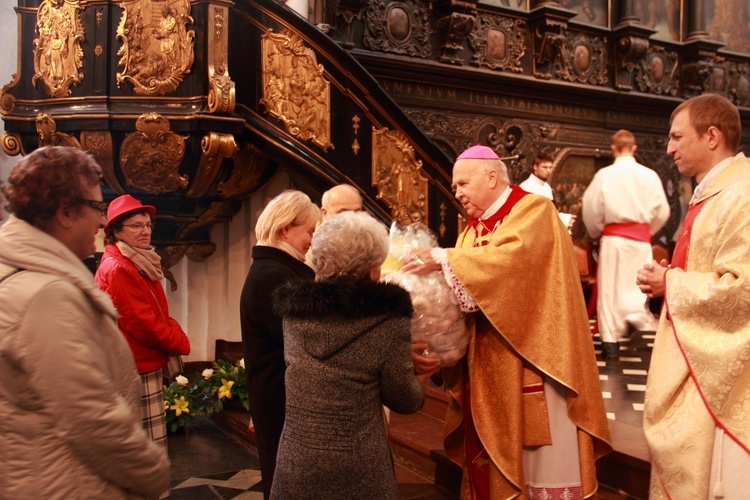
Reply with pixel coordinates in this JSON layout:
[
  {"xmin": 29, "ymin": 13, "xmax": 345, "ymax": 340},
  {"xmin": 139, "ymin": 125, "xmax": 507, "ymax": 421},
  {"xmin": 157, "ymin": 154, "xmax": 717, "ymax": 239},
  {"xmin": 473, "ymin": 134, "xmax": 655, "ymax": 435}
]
[{"xmin": 240, "ymin": 246, "xmax": 315, "ymax": 498}]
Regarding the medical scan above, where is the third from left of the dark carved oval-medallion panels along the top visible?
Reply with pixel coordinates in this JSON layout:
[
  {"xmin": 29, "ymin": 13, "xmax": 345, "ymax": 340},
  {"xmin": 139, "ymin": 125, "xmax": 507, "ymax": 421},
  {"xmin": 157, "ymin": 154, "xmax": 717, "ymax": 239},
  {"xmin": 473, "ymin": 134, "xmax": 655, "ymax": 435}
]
[{"xmin": 555, "ymin": 32, "xmax": 607, "ymax": 85}]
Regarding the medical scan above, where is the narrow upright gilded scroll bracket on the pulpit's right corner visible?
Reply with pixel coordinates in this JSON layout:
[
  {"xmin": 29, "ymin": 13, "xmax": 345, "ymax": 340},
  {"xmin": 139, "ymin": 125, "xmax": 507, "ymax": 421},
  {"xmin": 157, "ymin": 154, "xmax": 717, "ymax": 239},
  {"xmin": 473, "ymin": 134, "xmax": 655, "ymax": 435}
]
[{"xmin": 207, "ymin": 5, "xmax": 235, "ymax": 114}]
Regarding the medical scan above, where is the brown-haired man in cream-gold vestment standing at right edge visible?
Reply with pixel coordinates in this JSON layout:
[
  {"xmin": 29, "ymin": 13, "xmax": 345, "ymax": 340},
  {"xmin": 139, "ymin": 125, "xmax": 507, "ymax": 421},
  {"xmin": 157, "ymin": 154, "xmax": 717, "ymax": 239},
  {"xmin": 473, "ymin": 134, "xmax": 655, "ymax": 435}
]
[{"xmin": 637, "ymin": 94, "xmax": 750, "ymax": 500}]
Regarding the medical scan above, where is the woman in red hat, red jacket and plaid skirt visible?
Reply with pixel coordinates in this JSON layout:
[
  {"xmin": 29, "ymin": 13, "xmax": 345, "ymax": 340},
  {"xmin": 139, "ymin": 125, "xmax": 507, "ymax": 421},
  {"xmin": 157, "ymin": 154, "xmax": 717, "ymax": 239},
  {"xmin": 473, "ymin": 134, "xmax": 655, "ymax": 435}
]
[{"xmin": 96, "ymin": 194, "xmax": 190, "ymax": 451}]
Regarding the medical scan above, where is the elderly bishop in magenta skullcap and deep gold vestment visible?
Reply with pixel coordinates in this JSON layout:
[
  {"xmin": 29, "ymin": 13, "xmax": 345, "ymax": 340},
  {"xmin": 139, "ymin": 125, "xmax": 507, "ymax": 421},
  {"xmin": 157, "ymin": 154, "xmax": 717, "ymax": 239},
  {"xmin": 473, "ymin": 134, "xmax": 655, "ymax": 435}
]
[{"xmin": 404, "ymin": 146, "xmax": 611, "ymax": 499}]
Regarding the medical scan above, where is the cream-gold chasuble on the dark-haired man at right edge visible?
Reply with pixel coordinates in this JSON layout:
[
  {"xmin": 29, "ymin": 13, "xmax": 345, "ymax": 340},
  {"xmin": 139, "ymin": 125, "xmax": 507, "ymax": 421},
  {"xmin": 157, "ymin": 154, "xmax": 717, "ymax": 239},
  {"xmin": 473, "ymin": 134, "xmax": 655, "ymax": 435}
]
[{"xmin": 643, "ymin": 154, "xmax": 750, "ymax": 499}]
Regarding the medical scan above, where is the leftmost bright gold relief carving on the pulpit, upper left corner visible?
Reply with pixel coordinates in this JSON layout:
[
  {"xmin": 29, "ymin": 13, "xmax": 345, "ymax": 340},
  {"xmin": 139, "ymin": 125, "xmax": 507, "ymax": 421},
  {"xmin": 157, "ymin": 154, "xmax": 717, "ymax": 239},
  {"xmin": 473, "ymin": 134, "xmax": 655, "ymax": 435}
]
[{"xmin": 31, "ymin": 0, "xmax": 84, "ymax": 97}]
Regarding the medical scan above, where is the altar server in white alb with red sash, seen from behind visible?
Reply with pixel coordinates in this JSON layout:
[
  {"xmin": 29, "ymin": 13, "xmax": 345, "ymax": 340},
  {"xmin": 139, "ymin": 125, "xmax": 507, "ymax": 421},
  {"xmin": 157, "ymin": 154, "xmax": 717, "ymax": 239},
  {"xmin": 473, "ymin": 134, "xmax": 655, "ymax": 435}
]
[{"xmin": 582, "ymin": 130, "xmax": 669, "ymax": 357}]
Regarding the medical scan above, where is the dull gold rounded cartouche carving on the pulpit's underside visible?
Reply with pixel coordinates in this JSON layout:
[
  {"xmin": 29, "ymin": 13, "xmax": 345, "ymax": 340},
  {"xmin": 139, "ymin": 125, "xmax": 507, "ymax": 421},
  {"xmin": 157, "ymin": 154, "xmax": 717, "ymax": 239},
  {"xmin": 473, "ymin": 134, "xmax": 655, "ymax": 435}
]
[{"xmin": 120, "ymin": 113, "xmax": 188, "ymax": 194}]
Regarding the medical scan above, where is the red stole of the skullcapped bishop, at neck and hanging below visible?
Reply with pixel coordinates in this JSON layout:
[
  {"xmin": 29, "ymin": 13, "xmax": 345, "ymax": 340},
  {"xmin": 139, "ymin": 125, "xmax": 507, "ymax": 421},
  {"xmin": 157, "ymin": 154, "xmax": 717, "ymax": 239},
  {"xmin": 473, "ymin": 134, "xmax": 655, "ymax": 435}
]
[{"xmin": 463, "ymin": 185, "xmax": 529, "ymax": 500}]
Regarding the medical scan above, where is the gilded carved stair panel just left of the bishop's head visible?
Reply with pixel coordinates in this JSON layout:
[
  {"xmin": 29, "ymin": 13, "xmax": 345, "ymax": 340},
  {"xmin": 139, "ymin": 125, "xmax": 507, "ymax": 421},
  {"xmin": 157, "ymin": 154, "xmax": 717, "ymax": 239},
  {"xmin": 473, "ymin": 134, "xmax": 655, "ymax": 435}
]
[{"xmin": 372, "ymin": 127, "xmax": 427, "ymax": 224}]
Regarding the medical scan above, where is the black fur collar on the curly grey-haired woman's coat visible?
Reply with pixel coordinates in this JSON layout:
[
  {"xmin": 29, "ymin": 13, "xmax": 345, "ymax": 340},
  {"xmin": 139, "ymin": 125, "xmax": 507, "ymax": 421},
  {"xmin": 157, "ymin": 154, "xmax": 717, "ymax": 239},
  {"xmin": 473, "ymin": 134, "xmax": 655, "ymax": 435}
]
[{"xmin": 274, "ymin": 280, "xmax": 414, "ymax": 318}]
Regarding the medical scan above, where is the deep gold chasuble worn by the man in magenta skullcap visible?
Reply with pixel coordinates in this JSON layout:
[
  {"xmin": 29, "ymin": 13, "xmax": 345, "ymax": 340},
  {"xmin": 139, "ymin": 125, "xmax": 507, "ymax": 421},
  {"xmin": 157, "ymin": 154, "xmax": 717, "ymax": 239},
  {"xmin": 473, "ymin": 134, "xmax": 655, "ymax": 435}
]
[{"xmin": 442, "ymin": 186, "xmax": 612, "ymax": 499}]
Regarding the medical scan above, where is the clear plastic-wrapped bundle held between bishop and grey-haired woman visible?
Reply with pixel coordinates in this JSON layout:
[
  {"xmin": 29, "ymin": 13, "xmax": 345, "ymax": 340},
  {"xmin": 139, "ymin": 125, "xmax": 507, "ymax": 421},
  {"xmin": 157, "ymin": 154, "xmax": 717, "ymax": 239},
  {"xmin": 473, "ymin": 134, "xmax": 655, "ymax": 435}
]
[{"xmin": 383, "ymin": 222, "xmax": 468, "ymax": 367}]
